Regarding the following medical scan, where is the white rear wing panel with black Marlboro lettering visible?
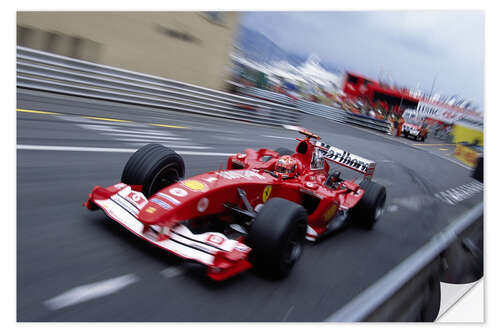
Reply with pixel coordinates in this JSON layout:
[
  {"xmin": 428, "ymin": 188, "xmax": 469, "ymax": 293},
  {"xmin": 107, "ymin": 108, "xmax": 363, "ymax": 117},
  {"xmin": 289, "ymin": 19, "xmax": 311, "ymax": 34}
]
[{"xmin": 314, "ymin": 141, "xmax": 377, "ymax": 179}]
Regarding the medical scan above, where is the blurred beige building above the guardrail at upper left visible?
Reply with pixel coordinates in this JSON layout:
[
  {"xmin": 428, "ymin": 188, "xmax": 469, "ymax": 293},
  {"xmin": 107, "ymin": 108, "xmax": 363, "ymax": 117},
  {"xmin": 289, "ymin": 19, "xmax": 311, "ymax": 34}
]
[{"xmin": 17, "ymin": 12, "xmax": 239, "ymax": 89}]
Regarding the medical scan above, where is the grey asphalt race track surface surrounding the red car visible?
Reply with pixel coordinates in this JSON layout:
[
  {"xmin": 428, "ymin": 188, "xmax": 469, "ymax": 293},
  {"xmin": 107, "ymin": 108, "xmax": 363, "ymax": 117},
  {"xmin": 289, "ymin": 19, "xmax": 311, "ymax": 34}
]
[{"xmin": 17, "ymin": 90, "xmax": 482, "ymax": 321}]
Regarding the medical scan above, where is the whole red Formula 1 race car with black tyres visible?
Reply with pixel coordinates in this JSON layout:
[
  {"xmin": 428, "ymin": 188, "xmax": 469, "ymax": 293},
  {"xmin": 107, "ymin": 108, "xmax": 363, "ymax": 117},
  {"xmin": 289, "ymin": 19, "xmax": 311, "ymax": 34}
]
[{"xmin": 84, "ymin": 130, "xmax": 386, "ymax": 280}]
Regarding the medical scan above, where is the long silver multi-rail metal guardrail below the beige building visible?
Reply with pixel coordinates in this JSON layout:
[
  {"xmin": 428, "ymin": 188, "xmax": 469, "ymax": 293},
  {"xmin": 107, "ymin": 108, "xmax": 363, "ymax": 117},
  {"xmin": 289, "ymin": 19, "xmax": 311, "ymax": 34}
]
[{"xmin": 16, "ymin": 46, "xmax": 302, "ymax": 125}]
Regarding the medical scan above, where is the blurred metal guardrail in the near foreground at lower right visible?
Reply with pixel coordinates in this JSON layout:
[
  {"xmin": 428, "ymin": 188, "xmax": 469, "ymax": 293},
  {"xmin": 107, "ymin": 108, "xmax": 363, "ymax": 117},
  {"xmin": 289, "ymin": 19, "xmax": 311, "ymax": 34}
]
[{"xmin": 326, "ymin": 202, "xmax": 483, "ymax": 322}]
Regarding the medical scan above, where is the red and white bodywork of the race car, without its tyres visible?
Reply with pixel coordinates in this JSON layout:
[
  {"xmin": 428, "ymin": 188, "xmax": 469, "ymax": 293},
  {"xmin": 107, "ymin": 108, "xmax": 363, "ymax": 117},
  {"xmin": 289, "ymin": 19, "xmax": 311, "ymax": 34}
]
[{"xmin": 84, "ymin": 132, "xmax": 375, "ymax": 280}]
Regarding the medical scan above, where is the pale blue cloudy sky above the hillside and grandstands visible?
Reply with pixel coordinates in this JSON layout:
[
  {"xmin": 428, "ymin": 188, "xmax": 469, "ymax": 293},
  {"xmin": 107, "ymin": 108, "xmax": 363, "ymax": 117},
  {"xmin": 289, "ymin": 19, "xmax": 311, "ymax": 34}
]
[{"xmin": 241, "ymin": 11, "xmax": 484, "ymax": 109}]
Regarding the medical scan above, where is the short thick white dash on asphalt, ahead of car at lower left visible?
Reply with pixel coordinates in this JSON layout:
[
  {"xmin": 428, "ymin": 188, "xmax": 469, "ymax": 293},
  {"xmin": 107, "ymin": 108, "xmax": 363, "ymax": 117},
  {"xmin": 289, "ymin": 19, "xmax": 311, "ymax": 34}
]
[{"xmin": 44, "ymin": 274, "xmax": 139, "ymax": 310}]
